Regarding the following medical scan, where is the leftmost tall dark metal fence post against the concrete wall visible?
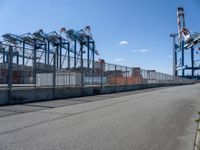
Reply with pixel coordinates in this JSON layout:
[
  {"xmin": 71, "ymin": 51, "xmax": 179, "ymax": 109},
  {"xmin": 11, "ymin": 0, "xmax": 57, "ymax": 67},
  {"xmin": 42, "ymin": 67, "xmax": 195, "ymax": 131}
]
[{"xmin": 8, "ymin": 46, "xmax": 13, "ymax": 103}]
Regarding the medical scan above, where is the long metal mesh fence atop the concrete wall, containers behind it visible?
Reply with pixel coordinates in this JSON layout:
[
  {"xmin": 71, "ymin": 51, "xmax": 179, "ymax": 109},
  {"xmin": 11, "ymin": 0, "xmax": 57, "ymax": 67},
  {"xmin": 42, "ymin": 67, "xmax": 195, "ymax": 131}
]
[{"xmin": 0, "ymin": 47, "xmax": 193, "ymax": 91}]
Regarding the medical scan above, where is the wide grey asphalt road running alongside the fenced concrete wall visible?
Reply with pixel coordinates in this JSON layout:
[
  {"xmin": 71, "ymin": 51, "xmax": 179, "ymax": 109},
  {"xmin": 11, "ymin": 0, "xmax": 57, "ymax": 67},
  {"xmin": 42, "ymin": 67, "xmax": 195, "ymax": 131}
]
[{"xmin": 0, "ymin": 84, "xmax": 200, "ymax": 150}]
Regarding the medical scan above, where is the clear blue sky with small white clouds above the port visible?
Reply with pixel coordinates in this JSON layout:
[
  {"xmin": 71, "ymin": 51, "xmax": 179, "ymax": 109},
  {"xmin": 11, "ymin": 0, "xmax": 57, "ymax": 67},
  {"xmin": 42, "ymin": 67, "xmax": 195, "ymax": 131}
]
[{"xmin": 0, "ymin": 0, "xmax": 200, "ymax": 74}]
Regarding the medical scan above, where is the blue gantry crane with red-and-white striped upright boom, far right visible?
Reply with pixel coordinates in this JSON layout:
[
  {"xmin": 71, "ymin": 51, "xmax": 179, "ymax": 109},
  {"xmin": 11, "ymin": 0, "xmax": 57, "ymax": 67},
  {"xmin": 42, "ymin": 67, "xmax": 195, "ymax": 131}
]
[{"xmin": 170, "ymin": 7, "xmax": 200, "ymax": 79}]
